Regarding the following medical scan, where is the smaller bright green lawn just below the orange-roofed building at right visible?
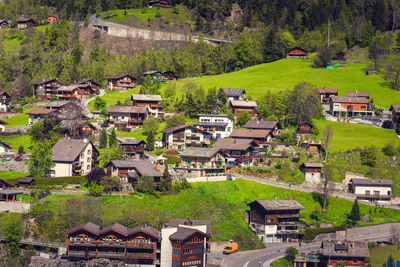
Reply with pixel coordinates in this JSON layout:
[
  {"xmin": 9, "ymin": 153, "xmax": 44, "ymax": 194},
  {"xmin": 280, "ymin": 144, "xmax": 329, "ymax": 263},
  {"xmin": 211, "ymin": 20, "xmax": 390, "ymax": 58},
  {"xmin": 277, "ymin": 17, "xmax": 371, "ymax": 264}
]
[{"xmin": 314, "ymin": 120, "xmax": 399, "ymax": 153}]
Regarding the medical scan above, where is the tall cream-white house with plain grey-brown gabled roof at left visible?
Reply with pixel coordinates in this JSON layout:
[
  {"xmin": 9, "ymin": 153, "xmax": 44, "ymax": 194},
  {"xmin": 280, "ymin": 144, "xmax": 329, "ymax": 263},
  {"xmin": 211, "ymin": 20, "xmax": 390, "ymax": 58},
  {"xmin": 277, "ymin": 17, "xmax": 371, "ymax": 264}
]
[{"xmin": 49, "ymin": 139, "xmax": 99, "ymax": 177}]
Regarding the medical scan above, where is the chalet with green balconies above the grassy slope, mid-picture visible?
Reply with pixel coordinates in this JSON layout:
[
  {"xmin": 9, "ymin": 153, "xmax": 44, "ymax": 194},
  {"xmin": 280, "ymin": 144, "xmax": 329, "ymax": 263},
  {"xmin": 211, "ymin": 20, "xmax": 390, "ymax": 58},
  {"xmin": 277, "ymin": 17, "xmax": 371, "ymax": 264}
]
[{"xmin": 174, "ymin": 147, "xmax": 225, "ymax": 178}]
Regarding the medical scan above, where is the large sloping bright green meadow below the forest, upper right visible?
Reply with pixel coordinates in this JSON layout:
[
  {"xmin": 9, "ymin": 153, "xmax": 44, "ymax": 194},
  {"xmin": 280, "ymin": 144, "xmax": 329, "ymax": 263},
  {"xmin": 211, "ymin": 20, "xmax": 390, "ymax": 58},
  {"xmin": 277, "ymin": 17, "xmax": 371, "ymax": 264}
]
[{"xmin": 170, "ymin": 59, "xmax": 400, "ymax": 109}]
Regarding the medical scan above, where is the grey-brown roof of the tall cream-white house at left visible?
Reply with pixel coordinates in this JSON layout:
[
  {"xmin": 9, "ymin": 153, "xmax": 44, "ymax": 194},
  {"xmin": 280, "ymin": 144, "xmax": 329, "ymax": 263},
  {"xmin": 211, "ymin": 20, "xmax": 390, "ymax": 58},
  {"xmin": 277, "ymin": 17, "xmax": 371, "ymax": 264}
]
[{"xmin": 51, "ymin": 139, "xmax": 90, "ymax": 162}]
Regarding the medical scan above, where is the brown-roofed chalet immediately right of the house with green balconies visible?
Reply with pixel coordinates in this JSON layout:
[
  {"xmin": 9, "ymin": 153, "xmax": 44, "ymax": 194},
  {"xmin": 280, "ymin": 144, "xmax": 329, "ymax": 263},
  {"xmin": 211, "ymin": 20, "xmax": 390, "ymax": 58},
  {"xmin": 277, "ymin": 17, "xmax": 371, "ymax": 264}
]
[{"xmin": 212, "ymin": 138, "xmax": 257, "ymax": 165}]
